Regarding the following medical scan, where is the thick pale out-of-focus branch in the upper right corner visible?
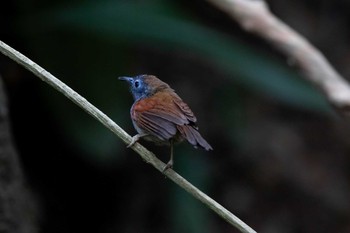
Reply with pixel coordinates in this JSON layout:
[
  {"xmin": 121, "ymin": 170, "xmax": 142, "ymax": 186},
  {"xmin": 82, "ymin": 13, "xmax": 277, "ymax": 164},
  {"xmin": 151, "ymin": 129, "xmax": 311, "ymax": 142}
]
[{"xmin": 207, "ymin": 0, "xmax": 350, "ymax": 116}]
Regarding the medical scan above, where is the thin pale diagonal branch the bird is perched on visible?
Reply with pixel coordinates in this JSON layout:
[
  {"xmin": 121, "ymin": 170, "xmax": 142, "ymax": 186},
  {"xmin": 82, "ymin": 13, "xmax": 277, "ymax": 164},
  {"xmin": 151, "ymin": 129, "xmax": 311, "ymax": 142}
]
[{"xmin": 0, "ymin": 41, "xmax": 255, "ymax": 233}]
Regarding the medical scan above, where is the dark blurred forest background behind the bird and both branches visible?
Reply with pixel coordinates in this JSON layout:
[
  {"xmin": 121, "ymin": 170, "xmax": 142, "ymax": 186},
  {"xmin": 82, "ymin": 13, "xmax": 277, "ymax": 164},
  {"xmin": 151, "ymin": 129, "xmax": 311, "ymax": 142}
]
[{"xmin": 0, "ymin": 0, "xmax": 350, "ymax": 233}]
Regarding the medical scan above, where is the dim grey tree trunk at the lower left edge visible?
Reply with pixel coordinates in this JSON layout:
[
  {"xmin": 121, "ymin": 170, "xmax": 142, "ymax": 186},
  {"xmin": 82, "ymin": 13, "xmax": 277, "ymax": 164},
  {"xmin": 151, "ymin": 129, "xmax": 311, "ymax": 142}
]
[{"xmin": 0, "ymin": 77, "xmax": 37, "ymax": 233}]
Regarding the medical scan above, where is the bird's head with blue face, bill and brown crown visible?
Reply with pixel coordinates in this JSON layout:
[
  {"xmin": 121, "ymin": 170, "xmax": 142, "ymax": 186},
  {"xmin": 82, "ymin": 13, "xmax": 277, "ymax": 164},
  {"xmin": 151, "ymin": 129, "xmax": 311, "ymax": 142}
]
[{"xmin": 119, "ymin": 74, "xmax": 172, "ymax": 100}]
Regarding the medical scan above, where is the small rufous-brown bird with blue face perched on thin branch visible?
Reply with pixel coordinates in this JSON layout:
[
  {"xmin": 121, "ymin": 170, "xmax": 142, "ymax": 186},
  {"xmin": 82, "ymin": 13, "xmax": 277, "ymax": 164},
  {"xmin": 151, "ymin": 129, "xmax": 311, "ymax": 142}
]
[{"xmin": 119, "ymin": 74, "xmax": 213, "ymax": 172}]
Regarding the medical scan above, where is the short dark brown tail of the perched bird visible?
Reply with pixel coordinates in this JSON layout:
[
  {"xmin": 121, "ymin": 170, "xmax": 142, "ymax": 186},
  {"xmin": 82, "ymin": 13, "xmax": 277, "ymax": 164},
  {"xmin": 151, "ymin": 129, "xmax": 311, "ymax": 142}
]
[{"xmin": 177, "ymin": 125, "xmax": 213, "ymax": 150}]
